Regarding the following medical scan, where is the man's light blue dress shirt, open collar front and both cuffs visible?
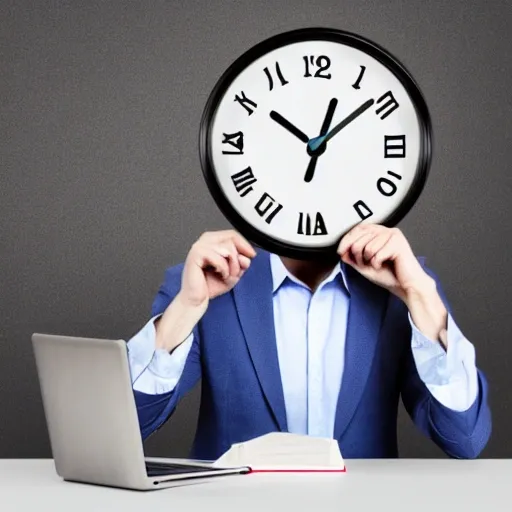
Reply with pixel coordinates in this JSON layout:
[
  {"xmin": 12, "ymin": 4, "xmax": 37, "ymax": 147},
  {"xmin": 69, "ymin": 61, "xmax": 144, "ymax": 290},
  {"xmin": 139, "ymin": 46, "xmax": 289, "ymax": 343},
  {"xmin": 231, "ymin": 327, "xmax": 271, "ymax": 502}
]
[{"xmin": 128, "ymin": 254, "xmax": 478, "ymax": 438}]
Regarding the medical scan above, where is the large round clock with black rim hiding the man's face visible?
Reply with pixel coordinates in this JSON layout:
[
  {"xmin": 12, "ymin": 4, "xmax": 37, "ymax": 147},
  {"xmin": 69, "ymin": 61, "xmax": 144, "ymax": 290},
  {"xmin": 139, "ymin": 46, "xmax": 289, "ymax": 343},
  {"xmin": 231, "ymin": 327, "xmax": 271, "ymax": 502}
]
[{"xmin": 200, "ymin": 29, "xmax": 430, "ymax": 259}]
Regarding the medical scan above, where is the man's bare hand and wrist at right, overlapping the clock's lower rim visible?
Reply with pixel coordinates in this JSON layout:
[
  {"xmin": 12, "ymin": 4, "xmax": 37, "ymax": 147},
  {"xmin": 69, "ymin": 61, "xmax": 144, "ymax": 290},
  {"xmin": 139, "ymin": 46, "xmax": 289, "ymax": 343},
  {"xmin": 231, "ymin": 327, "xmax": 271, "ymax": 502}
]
[{"xmin": 338, "ymin": 224, "xmax": 447, "ymax": 347}]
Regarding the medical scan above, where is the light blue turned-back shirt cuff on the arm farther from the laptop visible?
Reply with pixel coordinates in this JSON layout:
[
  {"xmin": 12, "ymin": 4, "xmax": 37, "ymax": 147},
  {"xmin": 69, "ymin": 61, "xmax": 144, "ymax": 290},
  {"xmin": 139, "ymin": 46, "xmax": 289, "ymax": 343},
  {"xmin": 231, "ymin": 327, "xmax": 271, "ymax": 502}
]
[{"xmin": 409, "ymin": 313, "xmax": 478, "ymax": 412}]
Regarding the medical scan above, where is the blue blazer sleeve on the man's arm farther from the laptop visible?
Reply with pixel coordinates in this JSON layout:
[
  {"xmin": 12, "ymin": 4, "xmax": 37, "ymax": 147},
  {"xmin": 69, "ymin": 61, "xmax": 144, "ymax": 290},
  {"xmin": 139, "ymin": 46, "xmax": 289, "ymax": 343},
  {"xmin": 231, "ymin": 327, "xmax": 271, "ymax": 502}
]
[{"xmin": 399, "ymin": 259, "xmax": 492, "ymax": 459}]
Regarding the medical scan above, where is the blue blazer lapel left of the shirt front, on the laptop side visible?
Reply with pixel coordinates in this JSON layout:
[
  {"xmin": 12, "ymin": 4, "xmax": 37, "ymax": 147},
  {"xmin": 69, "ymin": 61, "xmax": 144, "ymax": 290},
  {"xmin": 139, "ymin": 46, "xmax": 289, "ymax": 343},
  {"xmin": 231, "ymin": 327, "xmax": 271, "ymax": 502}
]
[{"xmin": 233, "ymin": 249, "xmax": 288, "ymax": 432}]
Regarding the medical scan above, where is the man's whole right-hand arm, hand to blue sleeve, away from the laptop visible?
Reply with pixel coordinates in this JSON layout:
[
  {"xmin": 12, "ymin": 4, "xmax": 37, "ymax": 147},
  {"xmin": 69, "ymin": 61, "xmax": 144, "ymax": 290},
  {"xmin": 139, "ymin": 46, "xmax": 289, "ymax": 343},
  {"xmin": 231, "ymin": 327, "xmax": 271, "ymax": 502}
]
[{"xmin": 338, "ymin": 224, "xmax": 491, "ymax": 458}]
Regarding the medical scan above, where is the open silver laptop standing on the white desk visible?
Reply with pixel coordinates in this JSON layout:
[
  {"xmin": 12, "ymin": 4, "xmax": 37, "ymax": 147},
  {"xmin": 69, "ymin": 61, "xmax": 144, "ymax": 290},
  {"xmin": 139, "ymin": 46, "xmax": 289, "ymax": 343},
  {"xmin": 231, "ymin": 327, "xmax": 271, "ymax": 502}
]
[{"xmin": 32, "ymin": 333, "xmax": 251, "ymax": 490}]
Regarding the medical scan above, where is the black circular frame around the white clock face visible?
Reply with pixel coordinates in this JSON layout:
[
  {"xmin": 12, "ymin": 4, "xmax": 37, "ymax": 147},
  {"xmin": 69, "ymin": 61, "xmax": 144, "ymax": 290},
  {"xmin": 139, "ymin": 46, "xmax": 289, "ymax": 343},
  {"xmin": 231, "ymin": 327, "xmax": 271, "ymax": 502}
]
[{"xmin": 199, "ymin": 27, "xmax": 432, "ymax": 260}]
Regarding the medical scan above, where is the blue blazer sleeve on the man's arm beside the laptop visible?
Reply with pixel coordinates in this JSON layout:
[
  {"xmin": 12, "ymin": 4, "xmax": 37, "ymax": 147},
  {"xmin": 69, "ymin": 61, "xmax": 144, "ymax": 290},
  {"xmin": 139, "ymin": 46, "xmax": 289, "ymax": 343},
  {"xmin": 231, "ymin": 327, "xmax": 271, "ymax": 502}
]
[{"xmin": 133, "ymin": 264, "xmax": 201, "ymax": 440}]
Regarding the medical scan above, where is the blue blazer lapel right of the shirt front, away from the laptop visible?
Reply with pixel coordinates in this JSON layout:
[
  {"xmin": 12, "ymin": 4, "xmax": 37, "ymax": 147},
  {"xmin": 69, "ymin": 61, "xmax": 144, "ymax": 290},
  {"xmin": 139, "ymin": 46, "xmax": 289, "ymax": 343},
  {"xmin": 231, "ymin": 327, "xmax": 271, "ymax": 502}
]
[{"xmin": 334, "ymin": 265, "xmax": 388, "ymax": 439}]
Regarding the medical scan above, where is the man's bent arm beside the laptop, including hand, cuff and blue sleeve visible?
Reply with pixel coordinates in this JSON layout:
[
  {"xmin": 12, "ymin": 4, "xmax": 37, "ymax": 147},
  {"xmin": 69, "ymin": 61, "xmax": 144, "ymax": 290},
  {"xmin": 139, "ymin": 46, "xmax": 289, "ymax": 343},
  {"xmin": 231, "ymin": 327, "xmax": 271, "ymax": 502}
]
[{"xmin": 129, "ymin": 230, "xmax": 256, "ymax": 439}]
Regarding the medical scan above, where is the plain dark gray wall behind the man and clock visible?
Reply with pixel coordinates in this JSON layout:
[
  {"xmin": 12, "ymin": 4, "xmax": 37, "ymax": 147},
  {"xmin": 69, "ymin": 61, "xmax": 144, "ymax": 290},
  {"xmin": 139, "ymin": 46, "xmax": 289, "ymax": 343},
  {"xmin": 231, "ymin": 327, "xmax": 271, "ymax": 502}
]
[{"xmin": 0, "ymin": 0, "xmax": 512, "ymax": 457}]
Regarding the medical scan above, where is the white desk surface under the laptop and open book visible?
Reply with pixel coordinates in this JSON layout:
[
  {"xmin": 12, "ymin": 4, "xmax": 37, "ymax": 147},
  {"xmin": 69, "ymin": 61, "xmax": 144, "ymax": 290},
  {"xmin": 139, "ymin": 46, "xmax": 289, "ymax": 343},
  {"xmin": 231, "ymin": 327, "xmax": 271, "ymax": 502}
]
[{"xmin": 0, "ymin": 459, "xmax": 512, "ymax": 512}]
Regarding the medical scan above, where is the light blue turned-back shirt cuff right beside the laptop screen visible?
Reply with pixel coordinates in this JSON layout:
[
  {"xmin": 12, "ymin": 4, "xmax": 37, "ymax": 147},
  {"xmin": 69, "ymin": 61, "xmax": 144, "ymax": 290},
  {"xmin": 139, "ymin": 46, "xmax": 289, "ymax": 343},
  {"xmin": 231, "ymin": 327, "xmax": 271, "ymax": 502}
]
[{"xmin": 128, "ymin": 314, "xmax": 194, "ymax": 395}]
